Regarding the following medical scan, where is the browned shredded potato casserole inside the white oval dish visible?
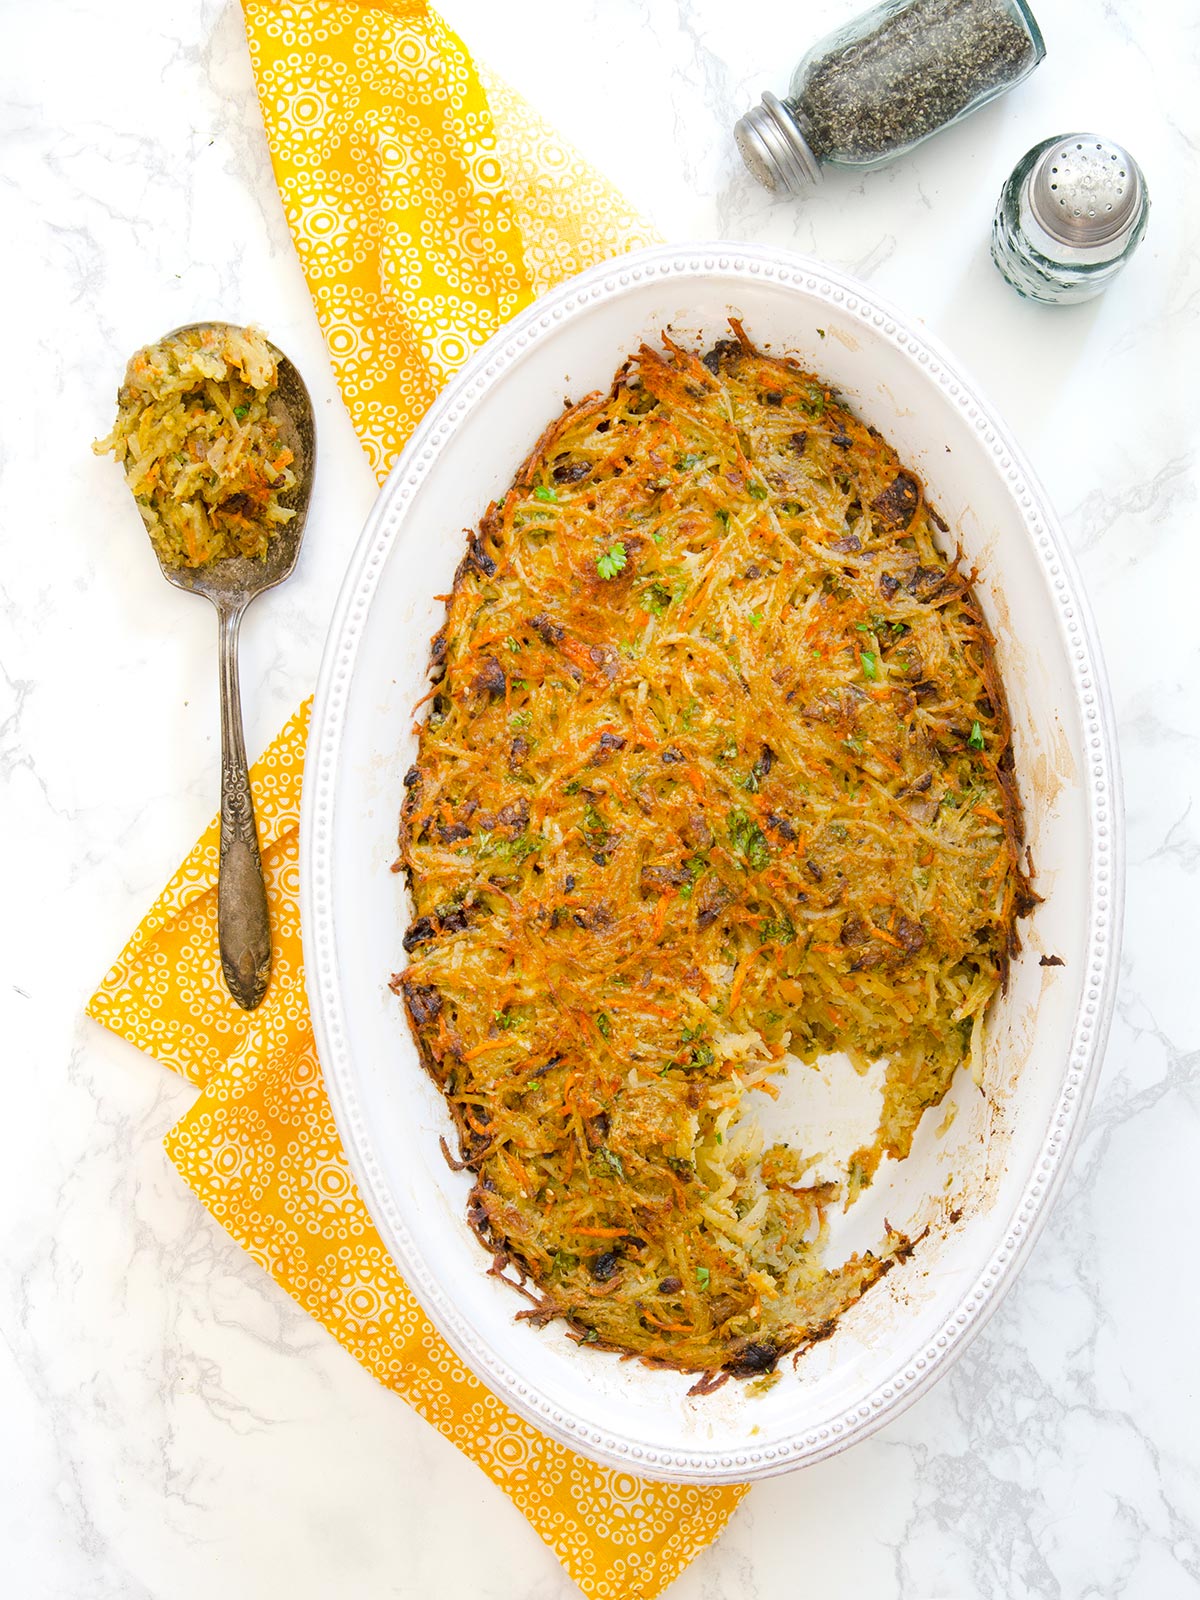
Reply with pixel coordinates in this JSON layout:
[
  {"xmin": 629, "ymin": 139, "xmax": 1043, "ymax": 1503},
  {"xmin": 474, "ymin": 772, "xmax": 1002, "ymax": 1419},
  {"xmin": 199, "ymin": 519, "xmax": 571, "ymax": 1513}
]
[{"xmin": 395, "ymin": 323, "xmax": 1034, "ymax": 1382}]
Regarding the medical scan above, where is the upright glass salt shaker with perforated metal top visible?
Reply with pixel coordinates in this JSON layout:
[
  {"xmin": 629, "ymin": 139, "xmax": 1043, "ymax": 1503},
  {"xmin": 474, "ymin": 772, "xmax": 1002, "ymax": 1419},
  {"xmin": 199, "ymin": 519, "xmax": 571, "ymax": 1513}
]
[{"xmin": 992, "ymin": 133, "xmax": 1150, "ymax": 306}]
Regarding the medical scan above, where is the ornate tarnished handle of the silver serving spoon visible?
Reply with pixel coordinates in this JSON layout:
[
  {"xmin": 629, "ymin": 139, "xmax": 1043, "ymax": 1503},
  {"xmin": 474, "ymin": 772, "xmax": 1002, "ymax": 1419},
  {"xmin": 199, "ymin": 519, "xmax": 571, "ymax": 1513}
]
[{"xmin": 216, "ymin": 605, "xmax": 270, "ymax": 1011}]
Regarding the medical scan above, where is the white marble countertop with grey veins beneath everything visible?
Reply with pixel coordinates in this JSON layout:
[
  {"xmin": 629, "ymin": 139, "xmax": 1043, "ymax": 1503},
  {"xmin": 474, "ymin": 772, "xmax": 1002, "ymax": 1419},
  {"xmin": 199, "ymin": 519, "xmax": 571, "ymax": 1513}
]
[{"xmin": 0, "ymin": 0, "xmax": 1200, "ymax": 1600}]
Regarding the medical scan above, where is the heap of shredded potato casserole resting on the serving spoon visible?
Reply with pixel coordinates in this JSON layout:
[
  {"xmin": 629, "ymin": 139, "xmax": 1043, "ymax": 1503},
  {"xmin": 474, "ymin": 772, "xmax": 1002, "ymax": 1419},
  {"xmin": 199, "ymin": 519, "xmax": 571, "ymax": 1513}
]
[{"xmin": 93, "ymin": 323, "xmax": 296, "ymax": 566}]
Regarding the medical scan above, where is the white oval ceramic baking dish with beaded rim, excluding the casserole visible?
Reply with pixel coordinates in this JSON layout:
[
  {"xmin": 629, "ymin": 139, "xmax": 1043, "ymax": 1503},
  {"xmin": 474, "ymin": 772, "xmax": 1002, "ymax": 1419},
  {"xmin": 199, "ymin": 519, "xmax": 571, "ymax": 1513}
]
[{"xmin": 301, "ymin": 243, "xmax": 1122, "ymax": 1483}]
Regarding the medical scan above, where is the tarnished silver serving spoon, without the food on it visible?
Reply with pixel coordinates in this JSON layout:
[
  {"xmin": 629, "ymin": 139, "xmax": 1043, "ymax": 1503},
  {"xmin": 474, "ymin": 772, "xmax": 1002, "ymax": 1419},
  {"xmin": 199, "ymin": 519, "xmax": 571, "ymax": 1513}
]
[{"xmin": 150, "ymin": 322, "xmax": 317, "ymax": 1011}]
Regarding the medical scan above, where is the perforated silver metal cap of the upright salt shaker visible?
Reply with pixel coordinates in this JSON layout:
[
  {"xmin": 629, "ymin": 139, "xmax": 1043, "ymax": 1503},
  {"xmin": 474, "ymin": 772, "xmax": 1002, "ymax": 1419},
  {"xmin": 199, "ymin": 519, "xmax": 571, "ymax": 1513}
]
[{"xmin": 1029, "ymin": 133, "xmax": 1142, "ymax": 256}]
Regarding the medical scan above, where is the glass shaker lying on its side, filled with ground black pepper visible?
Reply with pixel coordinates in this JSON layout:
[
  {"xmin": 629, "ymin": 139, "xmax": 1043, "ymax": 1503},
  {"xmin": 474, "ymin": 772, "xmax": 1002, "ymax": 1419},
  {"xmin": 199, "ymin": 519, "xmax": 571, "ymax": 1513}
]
[{"xmin": 734, "ymin": 0, "xmax": 1046, "ymax": 194}]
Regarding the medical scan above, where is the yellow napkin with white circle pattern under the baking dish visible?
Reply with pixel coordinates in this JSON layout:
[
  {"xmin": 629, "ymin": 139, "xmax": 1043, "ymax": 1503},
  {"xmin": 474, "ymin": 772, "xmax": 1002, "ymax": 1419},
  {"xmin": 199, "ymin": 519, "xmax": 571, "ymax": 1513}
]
[{"xmin": 88, "ymin": 0, "xmax": 746, "ymax": 1600}]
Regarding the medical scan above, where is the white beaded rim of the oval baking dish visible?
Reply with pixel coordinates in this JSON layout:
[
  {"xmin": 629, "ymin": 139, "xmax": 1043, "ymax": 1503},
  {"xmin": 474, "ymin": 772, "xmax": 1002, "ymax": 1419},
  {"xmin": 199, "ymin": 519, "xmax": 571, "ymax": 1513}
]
[{"xmin": 301, "ymin": 243, "xmax": 1123, "ymax": 1483}]
